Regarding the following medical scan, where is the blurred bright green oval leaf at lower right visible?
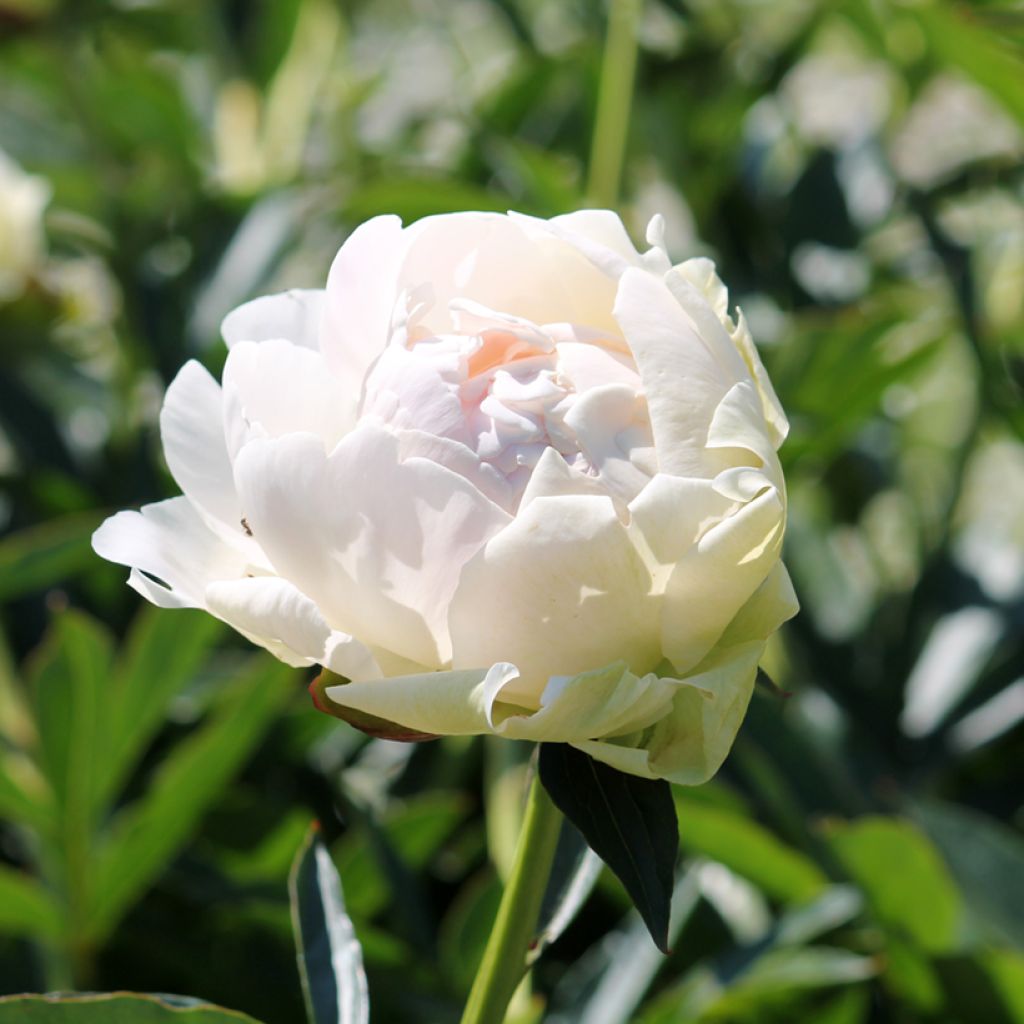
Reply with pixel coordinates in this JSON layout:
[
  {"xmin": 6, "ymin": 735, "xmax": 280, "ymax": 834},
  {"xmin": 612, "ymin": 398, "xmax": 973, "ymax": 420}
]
[{"xmin": 826, "ymin": 817, "xmax": 962, "ymax": 952}]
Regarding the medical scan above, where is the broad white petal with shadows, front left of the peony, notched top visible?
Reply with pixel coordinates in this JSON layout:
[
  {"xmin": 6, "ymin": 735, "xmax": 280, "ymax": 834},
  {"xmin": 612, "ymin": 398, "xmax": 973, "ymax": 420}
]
[{"xmin": 234, "ymin": 423, "xmax": 509, "ymax": 668}]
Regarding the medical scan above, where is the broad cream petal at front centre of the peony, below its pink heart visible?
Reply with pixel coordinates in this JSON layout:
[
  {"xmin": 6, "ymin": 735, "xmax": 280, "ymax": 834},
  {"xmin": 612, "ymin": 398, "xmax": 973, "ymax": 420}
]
[{"xmin": 449, "ymin": 495, "xmax": 660, "ymax": 708}]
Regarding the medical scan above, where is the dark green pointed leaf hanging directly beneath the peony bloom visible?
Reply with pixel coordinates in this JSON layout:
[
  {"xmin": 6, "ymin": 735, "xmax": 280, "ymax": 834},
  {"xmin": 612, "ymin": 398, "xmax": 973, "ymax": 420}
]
[{"xmin": 540, "ymin": 743, "xmax": 679, "ymax": 952}]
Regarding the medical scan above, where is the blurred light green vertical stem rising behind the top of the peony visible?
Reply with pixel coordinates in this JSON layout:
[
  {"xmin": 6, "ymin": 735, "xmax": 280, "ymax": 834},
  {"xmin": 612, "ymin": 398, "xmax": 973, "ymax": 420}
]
[{"xmin": 587, "ymin": 0, "xmax": 642, "ymax": 209}]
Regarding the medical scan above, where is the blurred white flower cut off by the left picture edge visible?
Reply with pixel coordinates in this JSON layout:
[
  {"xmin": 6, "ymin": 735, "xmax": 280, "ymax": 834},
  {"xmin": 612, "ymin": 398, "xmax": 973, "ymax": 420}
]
[{"xmin": 0, "ymin": 150, "xmax": 50, "ymax": 302}]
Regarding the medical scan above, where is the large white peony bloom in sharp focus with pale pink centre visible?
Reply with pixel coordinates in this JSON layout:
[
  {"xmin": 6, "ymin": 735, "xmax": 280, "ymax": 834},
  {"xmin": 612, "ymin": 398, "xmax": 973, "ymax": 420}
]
[{"xmin": 94, "ymin": 211, "xmax": 797, "ymax": 783}]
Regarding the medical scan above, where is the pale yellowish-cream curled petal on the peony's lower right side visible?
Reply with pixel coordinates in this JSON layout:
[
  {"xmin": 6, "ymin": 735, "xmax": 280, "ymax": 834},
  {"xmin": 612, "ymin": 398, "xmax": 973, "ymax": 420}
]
[{"xmin": 662, "ymin": 487, "xmax": 785, "ymax": 673}]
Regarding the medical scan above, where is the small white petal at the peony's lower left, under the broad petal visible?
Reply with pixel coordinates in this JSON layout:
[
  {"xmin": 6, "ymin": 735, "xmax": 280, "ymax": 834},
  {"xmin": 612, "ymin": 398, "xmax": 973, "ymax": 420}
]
[{"xmin": 206, "ymin": 577, "xmax": 381, "ymax": 679}]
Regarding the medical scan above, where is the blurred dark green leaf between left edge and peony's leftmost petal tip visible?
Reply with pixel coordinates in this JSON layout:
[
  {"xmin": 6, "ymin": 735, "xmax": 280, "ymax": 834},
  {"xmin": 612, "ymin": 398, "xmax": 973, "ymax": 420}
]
[{"xmin": 0, "ymin": 513, "xmax": 99, "ymax": 601}]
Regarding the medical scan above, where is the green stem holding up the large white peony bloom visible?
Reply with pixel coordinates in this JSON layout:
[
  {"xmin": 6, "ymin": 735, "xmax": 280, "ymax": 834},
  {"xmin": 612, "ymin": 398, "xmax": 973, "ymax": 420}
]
[{"xmin": 462, "ymin": 775, "xmax": 560, "ymax": 1024}]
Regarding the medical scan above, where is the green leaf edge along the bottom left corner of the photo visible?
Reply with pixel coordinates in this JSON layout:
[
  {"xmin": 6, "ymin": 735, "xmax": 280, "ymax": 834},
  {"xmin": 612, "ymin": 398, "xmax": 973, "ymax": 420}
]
[{"xmin": 0, "ymin": 992, "xmax": 259, "ymax": 1024}]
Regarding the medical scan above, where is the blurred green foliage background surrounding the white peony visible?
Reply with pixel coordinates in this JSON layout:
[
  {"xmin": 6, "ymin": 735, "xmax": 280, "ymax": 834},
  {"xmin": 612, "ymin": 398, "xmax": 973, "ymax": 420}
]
[{"xmin": 0, "ymin": 0, "xmax": 1024, "ymax": 1024}]
